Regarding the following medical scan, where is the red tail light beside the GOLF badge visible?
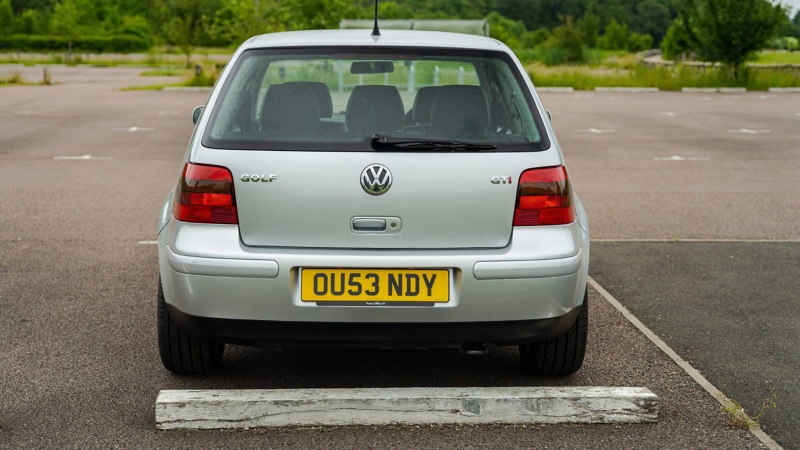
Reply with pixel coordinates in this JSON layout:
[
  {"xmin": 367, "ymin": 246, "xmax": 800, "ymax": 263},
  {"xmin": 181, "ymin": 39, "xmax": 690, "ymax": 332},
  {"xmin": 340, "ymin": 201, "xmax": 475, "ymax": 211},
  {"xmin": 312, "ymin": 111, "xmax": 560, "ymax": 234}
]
[{"xmin": 172, "ymin": 163, "xmax": 239, "ymax": 224}]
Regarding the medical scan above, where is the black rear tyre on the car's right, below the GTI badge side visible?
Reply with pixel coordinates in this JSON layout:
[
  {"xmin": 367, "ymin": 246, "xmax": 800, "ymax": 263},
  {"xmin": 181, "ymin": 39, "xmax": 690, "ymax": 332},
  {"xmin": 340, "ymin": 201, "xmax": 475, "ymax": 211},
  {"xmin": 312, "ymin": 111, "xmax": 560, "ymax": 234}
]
[{"xmin": 519, "ymin": 286, "xmax": 589, "ymax": 377}]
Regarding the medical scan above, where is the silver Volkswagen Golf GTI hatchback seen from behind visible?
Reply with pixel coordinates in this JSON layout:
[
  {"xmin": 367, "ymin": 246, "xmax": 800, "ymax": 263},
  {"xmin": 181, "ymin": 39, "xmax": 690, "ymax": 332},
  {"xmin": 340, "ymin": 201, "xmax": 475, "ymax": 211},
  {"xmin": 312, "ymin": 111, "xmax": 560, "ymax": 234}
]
[{"xmin": 158, "ymin": 30, "xmax": 589, "ymax": 375}]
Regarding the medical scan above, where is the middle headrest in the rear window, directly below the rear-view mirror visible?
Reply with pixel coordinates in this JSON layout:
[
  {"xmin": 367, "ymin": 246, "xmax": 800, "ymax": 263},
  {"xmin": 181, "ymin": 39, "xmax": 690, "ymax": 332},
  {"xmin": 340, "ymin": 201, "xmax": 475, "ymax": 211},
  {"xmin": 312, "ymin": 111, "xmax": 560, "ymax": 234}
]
[{"xmin": 345, "ymin": 85, "xmax": 405, "ymax": 133}]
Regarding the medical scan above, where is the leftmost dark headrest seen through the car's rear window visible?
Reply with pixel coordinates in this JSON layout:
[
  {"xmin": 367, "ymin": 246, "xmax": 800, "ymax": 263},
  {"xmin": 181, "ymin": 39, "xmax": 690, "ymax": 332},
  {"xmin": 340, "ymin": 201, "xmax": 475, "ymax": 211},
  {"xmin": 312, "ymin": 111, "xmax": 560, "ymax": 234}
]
[{"xmin": 261, "ymin": 83, "xmax": 319, "ymax": 131}]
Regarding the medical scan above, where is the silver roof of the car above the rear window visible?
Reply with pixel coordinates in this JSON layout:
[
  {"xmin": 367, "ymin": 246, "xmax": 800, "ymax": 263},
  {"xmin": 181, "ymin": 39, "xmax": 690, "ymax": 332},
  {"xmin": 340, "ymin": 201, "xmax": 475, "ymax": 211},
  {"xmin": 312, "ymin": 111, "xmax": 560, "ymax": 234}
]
[{"xmin": 245, "ymin": 30, "xmax": 508, "ymax": 51}]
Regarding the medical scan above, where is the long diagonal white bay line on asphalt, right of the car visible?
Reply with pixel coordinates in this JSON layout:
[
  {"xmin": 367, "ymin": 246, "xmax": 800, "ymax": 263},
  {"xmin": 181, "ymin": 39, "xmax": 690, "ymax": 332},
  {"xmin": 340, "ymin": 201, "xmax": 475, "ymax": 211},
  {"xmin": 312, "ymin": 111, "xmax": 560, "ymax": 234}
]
[{"xmin": 588, "ymin": 277, "xmax": 783, "ymax": 450}]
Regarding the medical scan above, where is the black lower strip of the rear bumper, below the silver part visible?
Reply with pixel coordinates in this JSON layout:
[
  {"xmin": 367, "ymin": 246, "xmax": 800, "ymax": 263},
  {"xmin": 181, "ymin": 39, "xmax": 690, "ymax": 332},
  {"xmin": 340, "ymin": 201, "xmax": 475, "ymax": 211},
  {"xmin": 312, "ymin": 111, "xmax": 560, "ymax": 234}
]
[{"xmin": 167, "ymin": 305, "xmax": 580, "ymax": 348}]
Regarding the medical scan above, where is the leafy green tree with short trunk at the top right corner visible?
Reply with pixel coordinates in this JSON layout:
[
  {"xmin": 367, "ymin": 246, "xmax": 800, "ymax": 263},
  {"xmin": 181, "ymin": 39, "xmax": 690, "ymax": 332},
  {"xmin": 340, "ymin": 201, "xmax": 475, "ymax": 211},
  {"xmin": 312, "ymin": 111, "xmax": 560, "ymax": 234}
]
[{"xmin": 678, "ymin": 0, "xmax": 786, "ymax": 80}]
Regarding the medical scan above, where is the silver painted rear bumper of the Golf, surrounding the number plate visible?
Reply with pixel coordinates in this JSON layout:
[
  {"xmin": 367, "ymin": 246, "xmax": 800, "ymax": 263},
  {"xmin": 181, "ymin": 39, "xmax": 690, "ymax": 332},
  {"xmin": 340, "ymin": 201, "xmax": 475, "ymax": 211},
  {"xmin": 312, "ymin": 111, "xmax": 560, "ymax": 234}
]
[{"xmin": 159, "ymin": 220, "xmax": 589, "ymax": 324}]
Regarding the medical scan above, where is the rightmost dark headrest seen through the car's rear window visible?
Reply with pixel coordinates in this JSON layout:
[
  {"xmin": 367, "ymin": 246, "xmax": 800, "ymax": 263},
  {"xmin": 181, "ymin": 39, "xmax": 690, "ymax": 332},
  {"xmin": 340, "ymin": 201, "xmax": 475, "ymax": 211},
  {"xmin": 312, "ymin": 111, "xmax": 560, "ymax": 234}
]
[{"xmin": 431, "ymin": 85, "xmax": 489, "ymax": 134}]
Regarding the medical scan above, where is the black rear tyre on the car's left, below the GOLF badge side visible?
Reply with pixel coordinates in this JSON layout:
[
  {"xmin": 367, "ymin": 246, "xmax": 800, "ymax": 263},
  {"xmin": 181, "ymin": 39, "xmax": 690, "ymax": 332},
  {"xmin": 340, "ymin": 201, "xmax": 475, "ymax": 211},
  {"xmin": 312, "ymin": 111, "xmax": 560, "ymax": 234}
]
[{"xmin": 158, "ymin": 278, "xmax": 225, "ymax": 375}]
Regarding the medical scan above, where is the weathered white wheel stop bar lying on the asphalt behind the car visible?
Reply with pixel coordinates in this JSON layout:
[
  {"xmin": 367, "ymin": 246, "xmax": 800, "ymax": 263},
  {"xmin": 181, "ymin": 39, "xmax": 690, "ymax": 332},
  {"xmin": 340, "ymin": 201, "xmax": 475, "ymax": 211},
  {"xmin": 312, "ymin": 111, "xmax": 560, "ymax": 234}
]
[{"xmin": 156, "ymin": 387, "xmax": 658, "ymax": 430}]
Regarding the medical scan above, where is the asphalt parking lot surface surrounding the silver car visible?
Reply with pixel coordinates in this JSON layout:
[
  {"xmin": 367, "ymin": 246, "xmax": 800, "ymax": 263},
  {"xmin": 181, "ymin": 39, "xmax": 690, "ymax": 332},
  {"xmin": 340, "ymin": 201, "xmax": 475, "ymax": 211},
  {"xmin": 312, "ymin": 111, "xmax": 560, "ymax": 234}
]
[{"xmin": 0, "ymin": 68, "xmax": 800, "ymax": 449}]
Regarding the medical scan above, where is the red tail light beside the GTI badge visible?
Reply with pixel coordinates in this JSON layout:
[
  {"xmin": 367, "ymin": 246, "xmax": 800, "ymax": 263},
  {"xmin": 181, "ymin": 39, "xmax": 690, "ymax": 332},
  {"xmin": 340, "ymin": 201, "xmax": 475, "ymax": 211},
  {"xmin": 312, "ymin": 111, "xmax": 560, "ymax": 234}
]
[{"xmin": 514, "ymin": 166, "xmax": 575, "ymax": 227}]
